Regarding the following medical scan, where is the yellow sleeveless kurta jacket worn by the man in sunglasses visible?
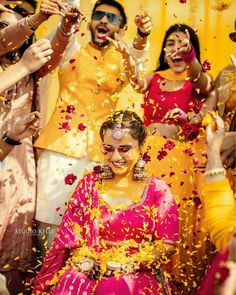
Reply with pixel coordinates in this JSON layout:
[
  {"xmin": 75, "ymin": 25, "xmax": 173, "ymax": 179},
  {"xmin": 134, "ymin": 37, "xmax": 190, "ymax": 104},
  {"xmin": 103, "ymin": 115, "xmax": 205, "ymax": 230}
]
[{"xmin": 35, "ymin": 44, "xmax": 124, "ymax": 161}]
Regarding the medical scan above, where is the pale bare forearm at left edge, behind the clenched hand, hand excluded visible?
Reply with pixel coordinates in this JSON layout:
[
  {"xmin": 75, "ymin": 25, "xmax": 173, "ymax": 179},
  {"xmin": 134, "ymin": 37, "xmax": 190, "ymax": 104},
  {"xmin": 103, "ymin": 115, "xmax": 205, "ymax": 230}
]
[{"xmin": 0, "ymin": 63, "xmax": 29, "ymax": 93}]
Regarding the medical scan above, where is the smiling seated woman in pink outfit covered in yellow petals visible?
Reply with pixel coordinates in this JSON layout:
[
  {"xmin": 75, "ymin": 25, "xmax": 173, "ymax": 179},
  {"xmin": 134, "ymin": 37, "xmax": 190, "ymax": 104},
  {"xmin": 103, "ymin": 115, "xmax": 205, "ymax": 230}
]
[{"xmin": 34, "ymin": 111, "xmax": 178, "ymax": 295}]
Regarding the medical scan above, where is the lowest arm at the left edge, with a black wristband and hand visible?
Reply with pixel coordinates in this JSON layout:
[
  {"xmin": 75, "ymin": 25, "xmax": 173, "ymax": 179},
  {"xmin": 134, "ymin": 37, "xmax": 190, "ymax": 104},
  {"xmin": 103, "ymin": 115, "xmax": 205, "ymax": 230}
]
[{"xmin": 0, "ymin": 112, "xmax": 41, "ymax": 161}]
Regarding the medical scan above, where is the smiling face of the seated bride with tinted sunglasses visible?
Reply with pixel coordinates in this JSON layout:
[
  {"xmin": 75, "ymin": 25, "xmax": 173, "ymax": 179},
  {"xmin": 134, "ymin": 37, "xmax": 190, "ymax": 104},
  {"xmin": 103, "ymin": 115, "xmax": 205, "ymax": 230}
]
[{"xmin": 101, "ymin": 129, "xmax": 141, "ymax": 175}]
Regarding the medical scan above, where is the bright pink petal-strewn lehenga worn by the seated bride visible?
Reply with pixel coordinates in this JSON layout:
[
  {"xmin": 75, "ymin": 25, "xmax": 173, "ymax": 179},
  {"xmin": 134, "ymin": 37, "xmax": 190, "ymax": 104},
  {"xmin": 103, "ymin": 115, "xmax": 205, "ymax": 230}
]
[{"xmin": 33, "ymin": 173, "xmax": 178, "ymax": 295}]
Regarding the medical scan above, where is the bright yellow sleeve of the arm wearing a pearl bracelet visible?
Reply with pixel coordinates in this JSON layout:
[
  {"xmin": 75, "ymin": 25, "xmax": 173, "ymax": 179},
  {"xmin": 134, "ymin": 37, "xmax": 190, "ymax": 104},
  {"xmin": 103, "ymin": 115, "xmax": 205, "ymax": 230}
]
[{"xmin": 204, "ymin": 179, "xmax": 236, "ymax": 250}]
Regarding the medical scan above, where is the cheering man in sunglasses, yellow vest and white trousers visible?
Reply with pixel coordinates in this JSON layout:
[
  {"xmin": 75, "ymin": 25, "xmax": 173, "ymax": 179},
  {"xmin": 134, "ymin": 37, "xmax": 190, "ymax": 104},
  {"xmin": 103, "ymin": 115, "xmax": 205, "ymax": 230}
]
[{"xmin": 35, "ymin": 0, "xmax": 152, "ymax": 254}]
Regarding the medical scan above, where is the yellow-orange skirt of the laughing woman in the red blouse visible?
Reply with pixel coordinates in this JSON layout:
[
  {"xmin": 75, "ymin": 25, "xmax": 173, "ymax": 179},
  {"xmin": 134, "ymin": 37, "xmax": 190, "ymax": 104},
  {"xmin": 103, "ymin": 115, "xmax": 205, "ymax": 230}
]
[{"xmin": 146, "ymin": 136, "xmax": 213, "ymax": 294}]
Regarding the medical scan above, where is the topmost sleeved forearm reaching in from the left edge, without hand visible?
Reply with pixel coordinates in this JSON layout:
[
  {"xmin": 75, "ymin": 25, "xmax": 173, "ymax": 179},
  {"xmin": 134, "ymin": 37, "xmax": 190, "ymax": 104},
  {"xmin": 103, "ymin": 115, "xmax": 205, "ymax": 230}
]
[{"xmin": 0, "ymin": 18, "xmax": 34, "ymax": 55}]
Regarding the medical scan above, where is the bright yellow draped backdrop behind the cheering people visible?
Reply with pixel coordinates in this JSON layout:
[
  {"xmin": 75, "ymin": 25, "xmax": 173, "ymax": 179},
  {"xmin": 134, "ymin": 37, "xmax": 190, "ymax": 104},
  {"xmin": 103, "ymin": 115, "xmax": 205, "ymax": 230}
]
[{"xmin": 37, "ymin": 0, "xmax": 236, "ymax": 121}]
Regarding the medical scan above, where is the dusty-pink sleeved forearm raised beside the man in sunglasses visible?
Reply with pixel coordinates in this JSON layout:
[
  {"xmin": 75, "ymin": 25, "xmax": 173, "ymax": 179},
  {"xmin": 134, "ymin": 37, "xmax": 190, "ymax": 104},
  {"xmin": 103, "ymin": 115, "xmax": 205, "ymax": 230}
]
[{"xmin": 37, "ymin": 28, "xmax": 72, "ymax": 77}]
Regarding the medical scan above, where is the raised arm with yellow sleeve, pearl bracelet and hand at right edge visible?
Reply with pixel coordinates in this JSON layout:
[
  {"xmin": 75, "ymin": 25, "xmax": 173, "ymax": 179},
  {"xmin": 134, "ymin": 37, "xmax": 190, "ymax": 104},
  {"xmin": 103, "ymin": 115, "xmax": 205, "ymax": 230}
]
[{"xmin": 204, "ymin": 115, "xmax": 236, "ymax": 249}]
